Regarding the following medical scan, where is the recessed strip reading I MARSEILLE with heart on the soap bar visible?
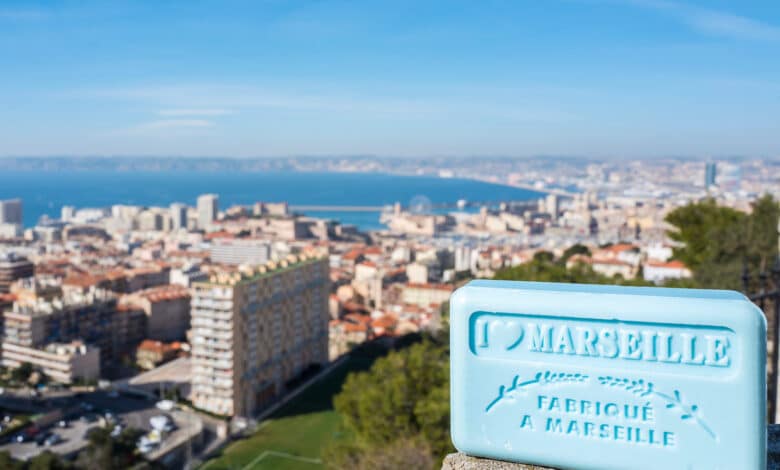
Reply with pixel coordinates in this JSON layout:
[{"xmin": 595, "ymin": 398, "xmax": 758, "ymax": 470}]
[{"xmin": 469, "ymin": 312, "xmax": 738, "ymax": 369}]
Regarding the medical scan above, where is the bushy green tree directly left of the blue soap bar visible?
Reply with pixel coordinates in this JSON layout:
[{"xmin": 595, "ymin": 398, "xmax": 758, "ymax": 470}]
[{"xmin": 326, "ymin": 340, "xmax": 452, "ymax": 468}]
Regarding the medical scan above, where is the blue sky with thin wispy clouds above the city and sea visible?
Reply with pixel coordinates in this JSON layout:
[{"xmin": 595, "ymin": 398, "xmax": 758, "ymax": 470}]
[{"xmin": 0, "ymin": 0, "xmax": 780, "ymax": 158}]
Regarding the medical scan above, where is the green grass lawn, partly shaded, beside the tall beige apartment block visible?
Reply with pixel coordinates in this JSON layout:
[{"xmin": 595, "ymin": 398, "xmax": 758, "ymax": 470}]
[{"xmin": 200, "ymin": 356, "xmax": 373, "ymax": 470}]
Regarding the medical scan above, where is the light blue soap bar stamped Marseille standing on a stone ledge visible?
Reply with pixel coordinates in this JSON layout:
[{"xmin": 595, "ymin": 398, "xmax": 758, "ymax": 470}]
[{"xmin": 450, "ymin": 281, "xmax": 766, "ymax": 470}]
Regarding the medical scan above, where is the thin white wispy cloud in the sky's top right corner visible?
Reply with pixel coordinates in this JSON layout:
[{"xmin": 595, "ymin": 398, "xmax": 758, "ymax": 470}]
[{"xmin": 619, "ymin": 0, "xmax": 780, "ymax": 41}]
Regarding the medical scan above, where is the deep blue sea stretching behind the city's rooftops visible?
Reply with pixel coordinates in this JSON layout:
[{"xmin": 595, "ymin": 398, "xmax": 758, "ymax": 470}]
[{"xmin": 0, "ymin": 171, "xmax": 542, "ymax": 230}]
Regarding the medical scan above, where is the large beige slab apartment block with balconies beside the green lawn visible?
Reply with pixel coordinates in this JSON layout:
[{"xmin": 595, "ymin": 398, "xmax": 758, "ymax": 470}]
[{"xmin": 191, "ymin": 255, "xmax": 330, "ymax": 416}]
